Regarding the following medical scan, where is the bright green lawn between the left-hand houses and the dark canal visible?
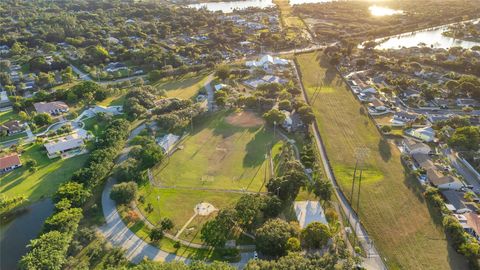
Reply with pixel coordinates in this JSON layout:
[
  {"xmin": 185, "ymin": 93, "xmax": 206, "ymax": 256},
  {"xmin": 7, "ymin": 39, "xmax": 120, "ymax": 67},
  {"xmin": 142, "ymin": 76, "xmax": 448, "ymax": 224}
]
[{"xmin": 0, "ymin": 144, "xmax": 88, "ymax": 202}]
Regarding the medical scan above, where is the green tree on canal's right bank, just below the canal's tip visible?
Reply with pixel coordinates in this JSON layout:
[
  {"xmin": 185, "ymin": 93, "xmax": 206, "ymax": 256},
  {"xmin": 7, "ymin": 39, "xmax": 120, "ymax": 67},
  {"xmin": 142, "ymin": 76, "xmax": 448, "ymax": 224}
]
[{"xmin": 43, "ymin": 208, "xmax": 83, "ymax": 234}]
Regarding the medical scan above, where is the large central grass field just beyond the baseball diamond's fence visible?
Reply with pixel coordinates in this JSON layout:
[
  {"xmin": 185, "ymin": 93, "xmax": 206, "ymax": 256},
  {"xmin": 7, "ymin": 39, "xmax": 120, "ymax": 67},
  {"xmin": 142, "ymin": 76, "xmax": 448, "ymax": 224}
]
[{"xmin": 153, "ymin": 112, "xmax": 278, "ymax": 191}]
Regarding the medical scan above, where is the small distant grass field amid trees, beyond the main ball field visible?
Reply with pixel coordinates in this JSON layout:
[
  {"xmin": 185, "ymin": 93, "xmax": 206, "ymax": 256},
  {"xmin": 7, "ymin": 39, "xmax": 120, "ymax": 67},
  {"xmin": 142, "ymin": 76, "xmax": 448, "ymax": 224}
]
[{"xmin": 154, "ymin": 73, "xmax": 213, "ymax": 99}]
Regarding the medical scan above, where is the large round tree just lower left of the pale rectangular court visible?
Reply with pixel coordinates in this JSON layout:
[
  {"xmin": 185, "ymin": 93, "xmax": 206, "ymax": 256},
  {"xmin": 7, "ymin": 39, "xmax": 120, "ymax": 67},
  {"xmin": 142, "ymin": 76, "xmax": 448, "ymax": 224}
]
[{"xmin": 255, "ymin": 218, "xmax": 296, "ymax": 257}]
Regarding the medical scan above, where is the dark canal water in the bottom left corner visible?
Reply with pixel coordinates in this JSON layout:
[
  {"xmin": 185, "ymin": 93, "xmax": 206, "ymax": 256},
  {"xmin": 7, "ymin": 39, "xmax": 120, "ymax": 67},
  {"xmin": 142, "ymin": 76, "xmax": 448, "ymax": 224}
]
[{"xmin": 0, "ymin": 199, "xmax": 53, "ymax": 270}]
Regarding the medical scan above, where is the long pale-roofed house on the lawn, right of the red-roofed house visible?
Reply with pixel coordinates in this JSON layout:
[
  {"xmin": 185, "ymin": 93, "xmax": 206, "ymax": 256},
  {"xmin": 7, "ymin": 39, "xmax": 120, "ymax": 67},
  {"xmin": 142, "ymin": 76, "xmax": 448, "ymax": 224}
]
[{"xmin": 44, "ymin": 133, "xmax": 85, "ymax": 158}]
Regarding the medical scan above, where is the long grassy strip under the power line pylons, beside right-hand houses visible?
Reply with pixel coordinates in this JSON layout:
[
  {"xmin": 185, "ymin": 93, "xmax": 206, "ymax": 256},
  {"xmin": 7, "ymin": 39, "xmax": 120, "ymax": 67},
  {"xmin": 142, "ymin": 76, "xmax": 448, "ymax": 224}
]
[{"xmin": 297, "ymin": 52, "xmax": 468, "ymax": 269}]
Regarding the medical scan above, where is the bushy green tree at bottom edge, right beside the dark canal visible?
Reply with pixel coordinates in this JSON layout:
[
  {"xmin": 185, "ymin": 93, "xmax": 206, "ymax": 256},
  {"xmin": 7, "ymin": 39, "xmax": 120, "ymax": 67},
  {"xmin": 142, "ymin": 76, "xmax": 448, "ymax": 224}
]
[{"xmin": 20, "ymin": 231, "xmax": 71, "ymax": 270}]
